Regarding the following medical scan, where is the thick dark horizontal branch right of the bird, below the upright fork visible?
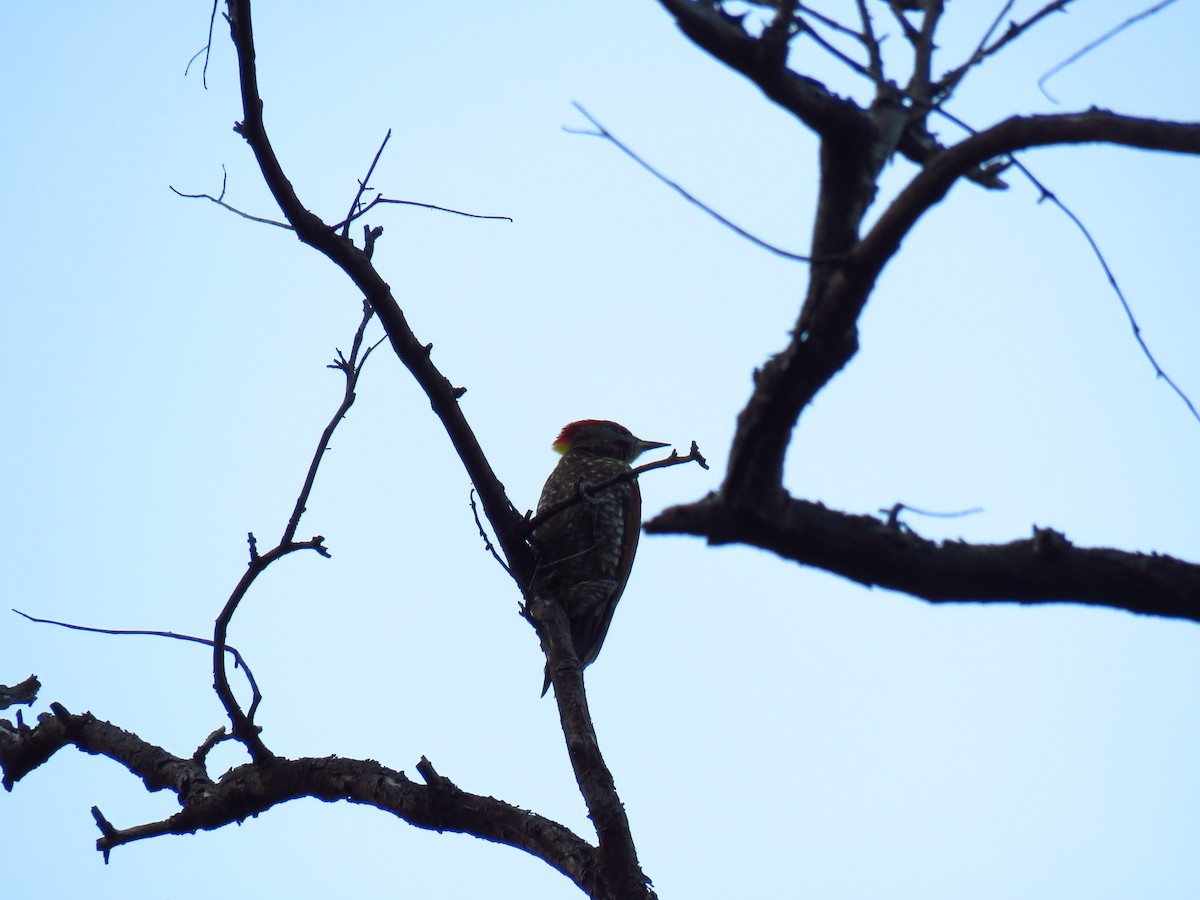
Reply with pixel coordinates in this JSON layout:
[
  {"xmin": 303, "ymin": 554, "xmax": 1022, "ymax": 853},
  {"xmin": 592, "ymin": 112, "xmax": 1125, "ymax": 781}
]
[{"xmin": 646, "ymin": 494, "xmax": 1200, "ymax": 622}]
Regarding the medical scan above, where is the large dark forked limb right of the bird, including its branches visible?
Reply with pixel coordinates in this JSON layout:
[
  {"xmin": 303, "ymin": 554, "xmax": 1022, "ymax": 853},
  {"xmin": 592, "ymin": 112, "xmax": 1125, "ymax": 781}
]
[{"xmin": 647, "ymin": 12, "xmax": 1200, "ymax": 618}]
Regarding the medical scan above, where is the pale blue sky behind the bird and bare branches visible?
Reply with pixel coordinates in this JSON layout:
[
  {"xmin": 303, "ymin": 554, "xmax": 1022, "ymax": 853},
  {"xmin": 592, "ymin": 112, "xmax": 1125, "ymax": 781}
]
[{"xmin": 0, "ymin": 0, "xmax": 1200, "ymax": 900}]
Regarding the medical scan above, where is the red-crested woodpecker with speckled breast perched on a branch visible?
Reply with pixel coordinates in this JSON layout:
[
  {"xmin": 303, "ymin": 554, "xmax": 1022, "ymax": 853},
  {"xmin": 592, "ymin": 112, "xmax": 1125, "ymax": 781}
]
[{"xmin": 530, "ymin": 419, "xmax": 668, "ymax": 697}]
